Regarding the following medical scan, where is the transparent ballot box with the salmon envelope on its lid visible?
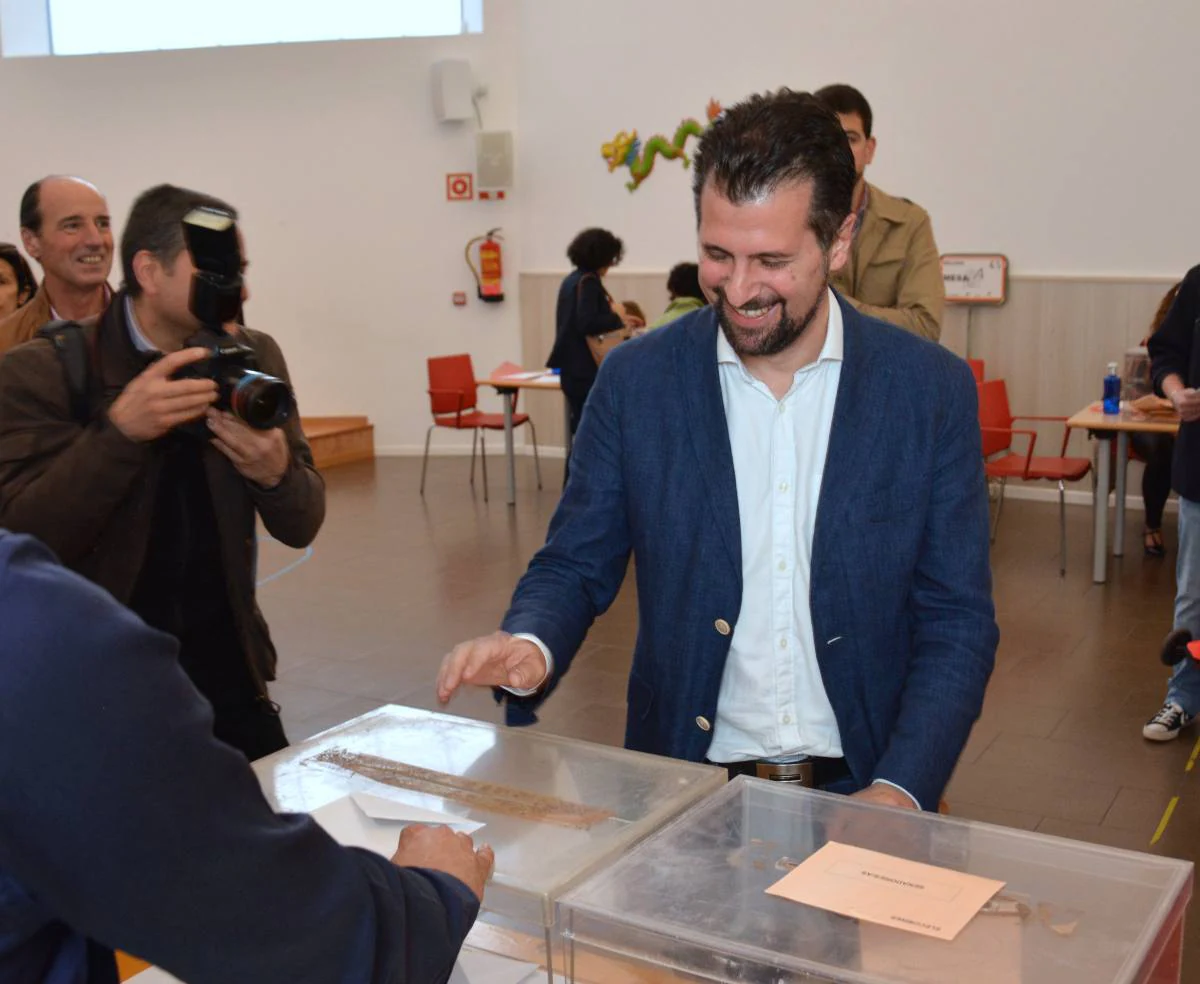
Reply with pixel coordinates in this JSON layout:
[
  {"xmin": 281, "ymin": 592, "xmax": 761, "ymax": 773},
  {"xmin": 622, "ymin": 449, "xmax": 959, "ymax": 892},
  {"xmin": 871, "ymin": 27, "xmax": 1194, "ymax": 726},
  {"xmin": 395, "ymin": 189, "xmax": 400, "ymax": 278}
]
[{"xmin": 558, "ymin": 778, "xmax": 1194, "ymax": 984}]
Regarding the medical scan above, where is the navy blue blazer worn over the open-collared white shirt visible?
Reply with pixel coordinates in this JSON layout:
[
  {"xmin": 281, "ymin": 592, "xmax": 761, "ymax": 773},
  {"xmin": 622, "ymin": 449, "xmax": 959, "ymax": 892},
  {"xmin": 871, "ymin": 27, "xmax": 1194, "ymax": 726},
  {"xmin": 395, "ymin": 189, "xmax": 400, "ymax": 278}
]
[{"xmin": 504, "ymin": 298, "xmax": 1000, "ymax": 809}]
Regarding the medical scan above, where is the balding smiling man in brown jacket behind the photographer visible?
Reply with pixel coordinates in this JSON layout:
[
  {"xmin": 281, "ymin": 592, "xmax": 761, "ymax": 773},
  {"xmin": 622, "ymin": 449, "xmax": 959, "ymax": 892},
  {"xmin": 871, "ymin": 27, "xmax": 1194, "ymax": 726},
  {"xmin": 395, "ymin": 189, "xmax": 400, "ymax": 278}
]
[{"xmin": 0, "ymin": 176, "xmax": 113, "ymax": 354}]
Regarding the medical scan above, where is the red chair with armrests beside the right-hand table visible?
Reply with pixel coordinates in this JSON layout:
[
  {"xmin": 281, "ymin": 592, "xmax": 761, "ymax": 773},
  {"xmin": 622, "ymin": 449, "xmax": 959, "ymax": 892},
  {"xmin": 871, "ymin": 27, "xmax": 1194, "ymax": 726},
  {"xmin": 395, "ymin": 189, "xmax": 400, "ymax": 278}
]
[{"xmin": 979, "ymin": 379, "xmax": 1092, "ymax": 576}]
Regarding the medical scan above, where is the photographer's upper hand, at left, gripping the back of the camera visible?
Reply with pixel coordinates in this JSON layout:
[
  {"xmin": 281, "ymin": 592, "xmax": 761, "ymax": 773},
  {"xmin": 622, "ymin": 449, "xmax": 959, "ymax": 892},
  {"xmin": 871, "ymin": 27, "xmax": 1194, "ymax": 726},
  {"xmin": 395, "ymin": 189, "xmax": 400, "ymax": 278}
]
[{"xmin": 108, "ymin": 348, "xmax": 217, "ymax": 443}]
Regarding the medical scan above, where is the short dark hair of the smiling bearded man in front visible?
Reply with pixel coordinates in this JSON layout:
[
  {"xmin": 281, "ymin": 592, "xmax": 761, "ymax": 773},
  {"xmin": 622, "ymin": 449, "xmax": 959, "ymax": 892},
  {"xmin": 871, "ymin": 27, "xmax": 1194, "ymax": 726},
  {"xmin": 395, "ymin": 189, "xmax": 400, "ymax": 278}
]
[{"xmin": 691, "ymin": 89, "xmax": 857, "ymax": 250}]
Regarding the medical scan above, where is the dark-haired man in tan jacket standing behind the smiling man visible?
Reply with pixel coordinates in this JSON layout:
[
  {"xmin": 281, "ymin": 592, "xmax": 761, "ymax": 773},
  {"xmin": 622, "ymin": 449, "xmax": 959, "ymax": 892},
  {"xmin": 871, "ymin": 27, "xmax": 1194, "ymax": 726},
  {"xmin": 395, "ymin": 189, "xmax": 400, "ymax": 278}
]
[{"xmin": 815, "ymin": 85, "xmax": 946, "ymax": 342}]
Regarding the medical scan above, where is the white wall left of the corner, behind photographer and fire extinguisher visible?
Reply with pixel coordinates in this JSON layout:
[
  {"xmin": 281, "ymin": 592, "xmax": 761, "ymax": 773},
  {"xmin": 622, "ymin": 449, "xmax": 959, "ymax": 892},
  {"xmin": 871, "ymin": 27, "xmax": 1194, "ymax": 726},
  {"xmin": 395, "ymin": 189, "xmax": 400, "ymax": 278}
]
[{"xmin": 0, "ymin": 4, "xmax": 521, "ymax": 448}]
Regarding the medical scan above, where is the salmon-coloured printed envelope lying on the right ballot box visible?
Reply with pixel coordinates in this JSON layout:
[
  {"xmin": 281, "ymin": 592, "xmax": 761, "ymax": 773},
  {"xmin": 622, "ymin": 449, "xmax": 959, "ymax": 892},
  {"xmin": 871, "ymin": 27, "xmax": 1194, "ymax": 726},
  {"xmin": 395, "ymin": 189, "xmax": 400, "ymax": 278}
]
[{"xmin": 767, "ymin": 841, "xmax": 1004, "ymax": 940}]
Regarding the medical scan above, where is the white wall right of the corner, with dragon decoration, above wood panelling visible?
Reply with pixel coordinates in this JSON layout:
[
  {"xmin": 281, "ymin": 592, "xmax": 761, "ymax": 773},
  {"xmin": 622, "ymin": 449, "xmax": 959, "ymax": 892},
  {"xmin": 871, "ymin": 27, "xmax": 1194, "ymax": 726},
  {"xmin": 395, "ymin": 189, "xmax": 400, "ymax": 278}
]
[{"xmin": 520, "ymin": 0, "xmax": 1200, "ymax": 275}]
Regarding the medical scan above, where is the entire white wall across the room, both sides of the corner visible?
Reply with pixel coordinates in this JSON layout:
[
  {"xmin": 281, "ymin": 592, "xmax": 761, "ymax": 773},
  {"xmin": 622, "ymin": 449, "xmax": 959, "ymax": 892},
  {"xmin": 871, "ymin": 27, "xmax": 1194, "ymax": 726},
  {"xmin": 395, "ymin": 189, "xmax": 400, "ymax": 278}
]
[{"xmin": 0, "ymin": 0, "xmax": 1200, "ymax": 449}]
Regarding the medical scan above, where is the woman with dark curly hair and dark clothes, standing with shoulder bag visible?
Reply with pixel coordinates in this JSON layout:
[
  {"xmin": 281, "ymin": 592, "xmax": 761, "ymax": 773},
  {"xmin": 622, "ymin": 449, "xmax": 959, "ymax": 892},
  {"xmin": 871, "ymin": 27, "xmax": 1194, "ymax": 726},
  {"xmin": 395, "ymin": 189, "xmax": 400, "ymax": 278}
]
[{"xmin": 546, "ymin": 228, "xmax": 629, "ymax": 436}]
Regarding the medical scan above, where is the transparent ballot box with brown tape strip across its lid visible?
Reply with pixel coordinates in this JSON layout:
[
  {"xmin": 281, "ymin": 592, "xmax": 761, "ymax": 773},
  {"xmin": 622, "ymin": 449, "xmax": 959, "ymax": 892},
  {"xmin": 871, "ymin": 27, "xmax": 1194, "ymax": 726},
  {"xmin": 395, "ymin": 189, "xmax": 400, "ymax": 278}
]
[{"xmin": 253, "ymin": 704, "xmax": 726, "ymax": 970}]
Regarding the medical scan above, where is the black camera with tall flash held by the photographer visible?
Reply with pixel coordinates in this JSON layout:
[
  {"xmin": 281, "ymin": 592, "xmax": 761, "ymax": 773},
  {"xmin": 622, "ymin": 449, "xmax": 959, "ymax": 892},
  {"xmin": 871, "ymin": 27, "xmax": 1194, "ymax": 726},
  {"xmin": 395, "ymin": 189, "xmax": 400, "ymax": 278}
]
[{"xmin": 176, "ymin": 208, "xmax": 295, "ymax": 431}]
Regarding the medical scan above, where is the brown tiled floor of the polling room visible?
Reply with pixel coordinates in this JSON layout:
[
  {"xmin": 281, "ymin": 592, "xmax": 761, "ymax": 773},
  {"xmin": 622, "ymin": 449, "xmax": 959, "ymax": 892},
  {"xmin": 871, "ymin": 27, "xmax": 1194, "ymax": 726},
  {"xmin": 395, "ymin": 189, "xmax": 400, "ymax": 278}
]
[{"xmin": 260, "ymin": 457, "xmax": 1200, "ymax": 982}]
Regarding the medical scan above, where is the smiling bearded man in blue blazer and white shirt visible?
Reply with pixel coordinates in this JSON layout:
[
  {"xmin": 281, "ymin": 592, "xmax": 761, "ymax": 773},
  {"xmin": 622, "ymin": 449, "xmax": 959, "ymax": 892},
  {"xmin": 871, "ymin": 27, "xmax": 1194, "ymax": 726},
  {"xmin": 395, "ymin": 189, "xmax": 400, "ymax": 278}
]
[{"xmin": 438, "ymin": 90, "xmax": 998, "ymax": 809}]
